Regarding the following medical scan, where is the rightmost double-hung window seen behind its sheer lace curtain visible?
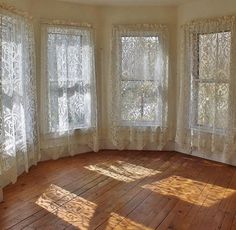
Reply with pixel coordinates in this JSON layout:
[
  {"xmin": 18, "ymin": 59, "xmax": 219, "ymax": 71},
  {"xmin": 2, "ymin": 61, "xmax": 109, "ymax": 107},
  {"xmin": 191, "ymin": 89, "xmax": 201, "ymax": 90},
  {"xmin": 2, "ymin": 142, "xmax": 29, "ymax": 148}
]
[{"xmin": 192, "ymin": 31, "xmax": 231, "ymax": 131}]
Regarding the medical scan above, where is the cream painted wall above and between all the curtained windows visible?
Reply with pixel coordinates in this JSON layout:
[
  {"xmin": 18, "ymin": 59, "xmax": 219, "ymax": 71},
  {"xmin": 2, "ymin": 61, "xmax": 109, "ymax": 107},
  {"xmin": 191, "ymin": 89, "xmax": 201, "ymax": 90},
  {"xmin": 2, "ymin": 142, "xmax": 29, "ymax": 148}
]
[{"xmin": 1, "ymin": 0, "xmax": 236, "ymax": 151}]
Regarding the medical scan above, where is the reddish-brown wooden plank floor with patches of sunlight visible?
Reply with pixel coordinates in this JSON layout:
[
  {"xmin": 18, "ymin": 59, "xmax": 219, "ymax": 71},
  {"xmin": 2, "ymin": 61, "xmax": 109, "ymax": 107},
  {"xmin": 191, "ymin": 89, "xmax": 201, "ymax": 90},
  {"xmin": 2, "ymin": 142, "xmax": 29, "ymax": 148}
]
[{"xmin": 0, "ymin": 151, "xmax": 236, "ymax": 230}]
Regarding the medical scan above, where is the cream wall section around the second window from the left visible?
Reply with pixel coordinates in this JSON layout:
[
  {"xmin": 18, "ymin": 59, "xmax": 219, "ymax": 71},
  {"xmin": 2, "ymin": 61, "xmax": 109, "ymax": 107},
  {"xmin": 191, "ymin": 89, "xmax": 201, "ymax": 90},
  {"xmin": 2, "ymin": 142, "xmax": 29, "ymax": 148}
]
[{"xmin": 30, "ymin": 0, "xmax": 104, "ymax": 150}]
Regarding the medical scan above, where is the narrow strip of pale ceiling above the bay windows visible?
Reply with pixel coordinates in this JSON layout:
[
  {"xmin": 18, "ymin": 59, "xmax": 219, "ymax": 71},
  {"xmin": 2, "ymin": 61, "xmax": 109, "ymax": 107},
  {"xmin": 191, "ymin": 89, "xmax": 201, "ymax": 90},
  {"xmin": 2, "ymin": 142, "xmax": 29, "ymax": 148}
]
[{"xmin": 57, "ymin": 0, "xmax": 193, "ymax": 6}]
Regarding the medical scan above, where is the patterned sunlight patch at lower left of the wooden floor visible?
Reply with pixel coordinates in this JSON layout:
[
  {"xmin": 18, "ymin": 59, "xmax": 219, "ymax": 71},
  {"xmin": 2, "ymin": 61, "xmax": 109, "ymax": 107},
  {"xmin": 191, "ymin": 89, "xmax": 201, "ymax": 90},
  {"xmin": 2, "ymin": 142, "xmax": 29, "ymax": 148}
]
[{"xmin": 36, "ymin": 185, "xmax": 97, "ymax": 229}]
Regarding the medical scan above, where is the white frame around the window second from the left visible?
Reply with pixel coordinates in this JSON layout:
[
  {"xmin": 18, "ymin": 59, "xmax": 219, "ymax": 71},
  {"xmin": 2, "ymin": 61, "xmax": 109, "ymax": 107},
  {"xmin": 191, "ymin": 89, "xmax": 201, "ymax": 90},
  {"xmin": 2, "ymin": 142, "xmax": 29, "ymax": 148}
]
[{"xmin": 41, "ymin": 22, "xmax": 97, "ymax": 136}]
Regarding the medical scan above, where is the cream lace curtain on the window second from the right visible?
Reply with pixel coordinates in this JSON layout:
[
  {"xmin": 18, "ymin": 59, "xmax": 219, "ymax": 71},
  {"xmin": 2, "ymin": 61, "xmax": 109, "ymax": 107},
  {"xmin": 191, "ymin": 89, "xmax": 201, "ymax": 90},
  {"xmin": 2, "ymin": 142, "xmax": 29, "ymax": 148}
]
[{"xmin": 109, "ymin": 24, "xmax": 168, "ymax": 149}]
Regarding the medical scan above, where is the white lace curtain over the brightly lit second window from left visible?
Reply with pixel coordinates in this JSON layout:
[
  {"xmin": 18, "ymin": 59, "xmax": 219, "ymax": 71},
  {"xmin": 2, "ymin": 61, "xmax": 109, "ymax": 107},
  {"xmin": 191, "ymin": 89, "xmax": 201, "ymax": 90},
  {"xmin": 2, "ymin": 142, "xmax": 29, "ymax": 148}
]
[{"xmin": 41, "ymin": 22, "xmax": 98, "ymax": 159}]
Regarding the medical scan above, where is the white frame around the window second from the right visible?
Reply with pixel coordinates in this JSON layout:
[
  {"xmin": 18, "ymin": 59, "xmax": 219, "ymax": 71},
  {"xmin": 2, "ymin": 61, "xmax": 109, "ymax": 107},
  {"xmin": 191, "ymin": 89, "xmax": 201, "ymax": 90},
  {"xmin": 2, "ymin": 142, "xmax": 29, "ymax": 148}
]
[{"xmin": 112, "ymin": 24, "xmax": 168, "ymax": 127}]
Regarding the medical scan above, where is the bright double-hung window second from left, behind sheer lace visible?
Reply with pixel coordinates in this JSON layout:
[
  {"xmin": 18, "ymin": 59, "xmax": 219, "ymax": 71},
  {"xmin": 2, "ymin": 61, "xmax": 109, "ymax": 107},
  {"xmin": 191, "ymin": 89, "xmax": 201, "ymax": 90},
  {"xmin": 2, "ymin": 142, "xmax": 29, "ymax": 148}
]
[{"xmin": 42, "ymin": 27, "xmax": 96, "ymax": 133}]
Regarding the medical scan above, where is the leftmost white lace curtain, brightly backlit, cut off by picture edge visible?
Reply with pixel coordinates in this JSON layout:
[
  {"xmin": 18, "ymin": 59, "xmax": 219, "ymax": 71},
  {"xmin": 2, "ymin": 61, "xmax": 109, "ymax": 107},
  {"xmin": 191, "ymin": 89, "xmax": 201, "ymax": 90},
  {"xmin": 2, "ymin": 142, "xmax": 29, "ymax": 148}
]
[{"xmin": 0, "ymin": 9, "xmax": 40, "ymax": 186}]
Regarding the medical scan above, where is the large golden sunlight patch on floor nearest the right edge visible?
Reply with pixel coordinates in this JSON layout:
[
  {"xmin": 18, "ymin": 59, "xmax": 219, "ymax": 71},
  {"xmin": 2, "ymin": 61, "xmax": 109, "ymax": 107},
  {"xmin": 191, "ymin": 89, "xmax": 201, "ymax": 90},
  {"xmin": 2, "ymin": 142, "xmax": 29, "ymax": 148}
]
[{"xmin": 142, "ymin": 176, "xmax": 236, "ymax": 207}]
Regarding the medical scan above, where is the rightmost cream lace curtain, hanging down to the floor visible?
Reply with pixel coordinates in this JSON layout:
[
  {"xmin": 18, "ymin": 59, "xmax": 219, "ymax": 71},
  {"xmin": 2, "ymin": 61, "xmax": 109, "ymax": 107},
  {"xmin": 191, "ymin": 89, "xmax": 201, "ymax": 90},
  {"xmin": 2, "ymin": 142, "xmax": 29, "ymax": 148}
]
[{"xmin": 176, "ymin": 17, "xmax": 236, "ymax": 164}]
